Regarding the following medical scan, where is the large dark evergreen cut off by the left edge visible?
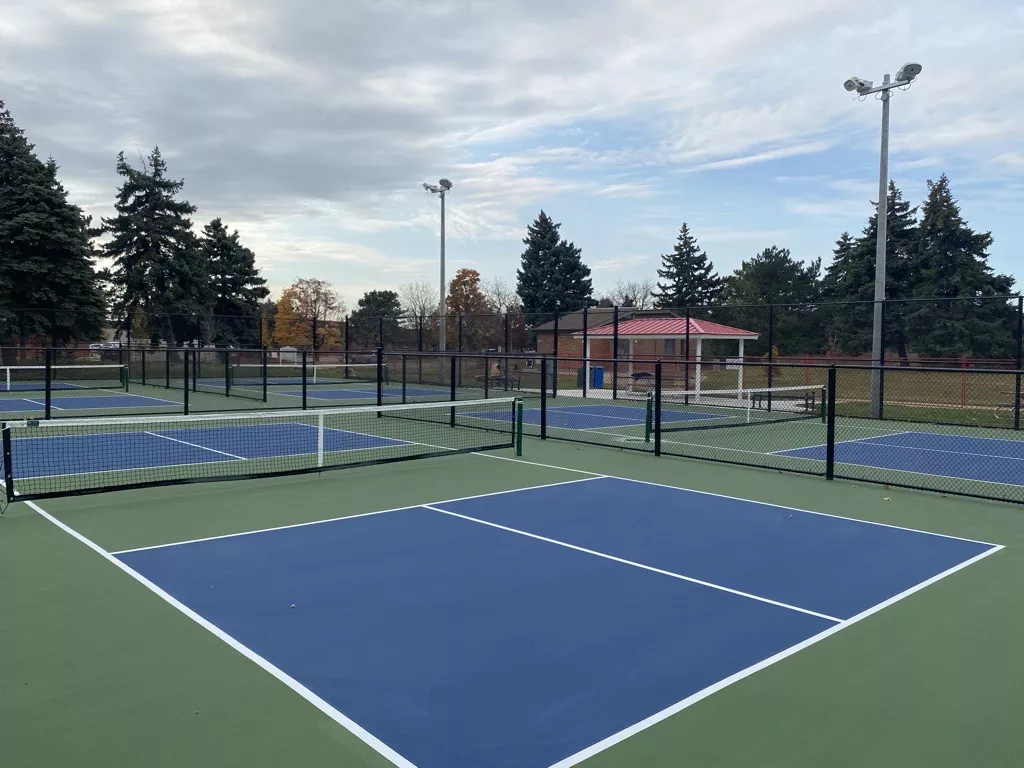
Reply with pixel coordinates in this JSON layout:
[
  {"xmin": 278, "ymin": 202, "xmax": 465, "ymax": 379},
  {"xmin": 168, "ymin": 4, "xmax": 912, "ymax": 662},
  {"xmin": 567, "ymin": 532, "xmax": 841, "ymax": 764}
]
[{"xmin": 0, "ymin": 101, "xmax": 105, "ymax": 345}]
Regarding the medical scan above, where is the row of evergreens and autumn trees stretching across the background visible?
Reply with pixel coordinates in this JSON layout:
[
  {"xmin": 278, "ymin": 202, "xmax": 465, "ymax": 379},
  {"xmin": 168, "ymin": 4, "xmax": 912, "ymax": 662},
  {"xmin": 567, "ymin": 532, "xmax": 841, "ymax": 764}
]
[{"xmin": 0, "ymin": 96, "xmax": 1016, "ymax": 357}]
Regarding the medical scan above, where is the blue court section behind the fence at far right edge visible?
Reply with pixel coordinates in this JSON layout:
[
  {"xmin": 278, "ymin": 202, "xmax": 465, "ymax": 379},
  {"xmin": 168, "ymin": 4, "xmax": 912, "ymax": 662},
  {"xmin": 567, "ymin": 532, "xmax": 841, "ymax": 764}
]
[{"xmin": 778, "ymin": 432, "xmax": 1024, "ymax": 485}]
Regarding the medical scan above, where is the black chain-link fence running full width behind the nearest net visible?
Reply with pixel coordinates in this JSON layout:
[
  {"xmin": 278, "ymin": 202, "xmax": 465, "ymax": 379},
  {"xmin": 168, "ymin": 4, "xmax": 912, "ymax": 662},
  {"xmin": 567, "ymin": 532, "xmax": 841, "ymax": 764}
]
[{"xmin": 0, "ymin": 348, "xmax": 1024, "ymax": 503}]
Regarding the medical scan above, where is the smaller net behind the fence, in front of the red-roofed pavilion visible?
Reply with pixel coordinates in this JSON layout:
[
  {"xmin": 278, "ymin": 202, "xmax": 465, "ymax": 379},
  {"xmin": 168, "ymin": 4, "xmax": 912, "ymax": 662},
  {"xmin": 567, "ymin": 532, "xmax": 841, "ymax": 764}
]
[{"xmin": 662, "ymin": 385, "xmax": 824, "ymax": 432}]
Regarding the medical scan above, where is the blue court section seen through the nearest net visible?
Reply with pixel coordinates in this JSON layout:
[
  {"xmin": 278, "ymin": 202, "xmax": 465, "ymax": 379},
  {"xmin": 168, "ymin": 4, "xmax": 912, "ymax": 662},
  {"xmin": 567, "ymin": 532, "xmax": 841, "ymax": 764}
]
[{"xmin": 11, "ymin": 421, "xmax": 412, "ymax": 479}]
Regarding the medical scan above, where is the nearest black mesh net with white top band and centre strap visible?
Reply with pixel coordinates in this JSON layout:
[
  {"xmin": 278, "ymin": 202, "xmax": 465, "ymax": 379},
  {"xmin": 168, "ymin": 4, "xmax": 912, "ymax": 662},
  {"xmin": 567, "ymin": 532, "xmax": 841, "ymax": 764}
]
[{"xmin": 3, "ymin": 398, "xmax": 521, "ymax": 500}]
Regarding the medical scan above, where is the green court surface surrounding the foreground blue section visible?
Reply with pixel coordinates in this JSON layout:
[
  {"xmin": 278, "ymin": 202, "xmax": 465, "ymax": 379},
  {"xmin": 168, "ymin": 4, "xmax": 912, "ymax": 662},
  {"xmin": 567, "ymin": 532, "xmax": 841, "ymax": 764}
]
[{"xmin": 0, "ymin": 438, "xmax": 1024, "ymax": 768}]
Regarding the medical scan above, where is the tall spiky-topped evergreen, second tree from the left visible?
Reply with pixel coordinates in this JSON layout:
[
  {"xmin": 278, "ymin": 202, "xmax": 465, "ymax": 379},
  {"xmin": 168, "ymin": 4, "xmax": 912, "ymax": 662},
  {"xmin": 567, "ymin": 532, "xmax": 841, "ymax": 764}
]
[{"xmin": 103, "ymin": 147, "xmax": 207, "ymax": 343}]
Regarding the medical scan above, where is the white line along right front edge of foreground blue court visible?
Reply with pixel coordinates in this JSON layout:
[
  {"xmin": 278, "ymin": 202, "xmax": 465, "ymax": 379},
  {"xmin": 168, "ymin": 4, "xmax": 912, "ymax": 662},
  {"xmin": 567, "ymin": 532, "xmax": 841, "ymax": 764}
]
[{"xmin": 551, "ymin": 545, "xmax": 1002, "ymax": 768}]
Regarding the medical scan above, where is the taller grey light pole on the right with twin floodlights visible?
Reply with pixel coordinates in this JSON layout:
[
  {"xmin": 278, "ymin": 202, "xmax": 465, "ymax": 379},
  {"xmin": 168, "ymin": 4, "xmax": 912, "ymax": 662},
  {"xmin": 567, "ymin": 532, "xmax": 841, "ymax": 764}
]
[{"xmin": 843, "ymin": 61, "xmax": 921, "ymax": 419}]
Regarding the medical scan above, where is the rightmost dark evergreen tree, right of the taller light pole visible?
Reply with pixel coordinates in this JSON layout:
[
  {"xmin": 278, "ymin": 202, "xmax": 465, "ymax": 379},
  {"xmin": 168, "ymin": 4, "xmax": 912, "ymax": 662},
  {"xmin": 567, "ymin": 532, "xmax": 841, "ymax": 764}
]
[{"xmin": 906, "ymin": 174, "xmax": 1016, "ymax": 357}]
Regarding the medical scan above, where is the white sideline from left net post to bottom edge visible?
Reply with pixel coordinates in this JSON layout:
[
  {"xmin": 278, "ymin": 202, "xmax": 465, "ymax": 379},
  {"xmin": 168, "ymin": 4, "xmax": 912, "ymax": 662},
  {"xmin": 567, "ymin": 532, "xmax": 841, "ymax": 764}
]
[{"xmin": 26, "ymin": 502, "xmax": 416, "ymax": 768}]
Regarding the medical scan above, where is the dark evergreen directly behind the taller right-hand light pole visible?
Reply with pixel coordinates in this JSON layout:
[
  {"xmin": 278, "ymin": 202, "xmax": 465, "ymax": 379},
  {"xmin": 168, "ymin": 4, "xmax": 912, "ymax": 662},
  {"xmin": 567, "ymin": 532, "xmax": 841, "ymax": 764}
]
[{"xmin": 822, "ymin": 181, "xmax": 918, "ymax": 360}]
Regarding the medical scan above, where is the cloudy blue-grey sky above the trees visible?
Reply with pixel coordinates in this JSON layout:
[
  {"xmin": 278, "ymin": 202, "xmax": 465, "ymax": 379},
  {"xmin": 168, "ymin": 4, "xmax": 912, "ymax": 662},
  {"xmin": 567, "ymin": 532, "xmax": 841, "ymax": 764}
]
[{"xmin": 0, "ymin": 0, "xmax": 1024, "ymax": 308}]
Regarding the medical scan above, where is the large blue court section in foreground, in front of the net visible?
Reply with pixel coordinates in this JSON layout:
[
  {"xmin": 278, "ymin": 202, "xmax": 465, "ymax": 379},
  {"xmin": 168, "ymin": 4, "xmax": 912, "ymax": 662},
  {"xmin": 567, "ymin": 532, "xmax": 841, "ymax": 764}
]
[{"xmin": 115, "ymin": 477, "xmax": 999, "ymax": 768}]
